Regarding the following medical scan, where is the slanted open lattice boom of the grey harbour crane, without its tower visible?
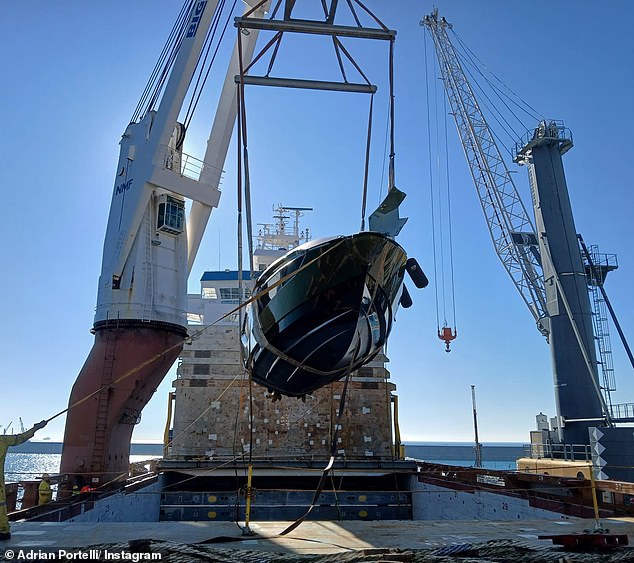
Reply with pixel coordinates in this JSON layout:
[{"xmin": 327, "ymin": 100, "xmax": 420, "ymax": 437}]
[{"xmin": 421, "ymin": 10, "xmax": 548, "ymax": 336}]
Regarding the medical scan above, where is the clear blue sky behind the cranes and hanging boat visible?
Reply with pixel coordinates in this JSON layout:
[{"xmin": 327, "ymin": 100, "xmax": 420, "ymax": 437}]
[{"xmin": 0, "ymin": 0, "xmax": 634, "ymax": 448}]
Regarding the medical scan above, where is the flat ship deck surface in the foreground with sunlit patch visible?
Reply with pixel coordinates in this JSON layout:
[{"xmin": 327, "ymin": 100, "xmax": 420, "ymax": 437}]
[{"xmin": 0, "ymin": 518, "xmax": 634, "ymax": 561}]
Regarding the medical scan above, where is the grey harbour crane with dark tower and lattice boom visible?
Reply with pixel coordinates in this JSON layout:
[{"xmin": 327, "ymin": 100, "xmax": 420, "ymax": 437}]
[{"xmin": 421, "ymin": 10, "xmax": 613, "ymax": 454}]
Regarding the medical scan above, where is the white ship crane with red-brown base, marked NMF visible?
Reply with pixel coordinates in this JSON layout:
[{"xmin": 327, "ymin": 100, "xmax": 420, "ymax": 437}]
[{"xmin": 61, "ymin": 0, "xmax": 269, "ymax": 484}]
